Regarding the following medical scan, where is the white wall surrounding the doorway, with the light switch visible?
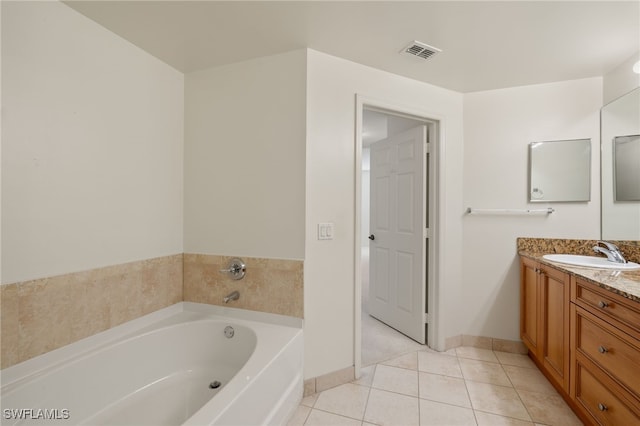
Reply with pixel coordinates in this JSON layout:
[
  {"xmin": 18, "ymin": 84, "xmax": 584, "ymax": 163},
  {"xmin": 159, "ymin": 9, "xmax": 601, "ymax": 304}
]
[{"xmin": 304, "ymin": 50, "xmax": 463, "ymax": 377}]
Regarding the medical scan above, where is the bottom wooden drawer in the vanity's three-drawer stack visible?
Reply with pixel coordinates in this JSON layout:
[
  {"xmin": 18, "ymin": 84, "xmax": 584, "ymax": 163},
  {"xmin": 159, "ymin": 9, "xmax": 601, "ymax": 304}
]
[{"xmin": 575, "ymin": 362, "xmax": 640, "ymax": 426}]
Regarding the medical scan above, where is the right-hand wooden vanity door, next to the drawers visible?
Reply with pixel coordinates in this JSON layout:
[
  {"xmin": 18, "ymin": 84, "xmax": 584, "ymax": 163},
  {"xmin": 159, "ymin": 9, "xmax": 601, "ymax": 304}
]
[{"xmin": 539, "ymin": 265, "xmax": 570, "ymax": 391}]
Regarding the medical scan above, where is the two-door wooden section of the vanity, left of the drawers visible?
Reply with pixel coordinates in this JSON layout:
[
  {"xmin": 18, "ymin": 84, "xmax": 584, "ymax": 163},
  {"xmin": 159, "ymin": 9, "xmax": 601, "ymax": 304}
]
[{"xmin": 520, "ymin": 257, "xmax": 571, "ymax": 392}]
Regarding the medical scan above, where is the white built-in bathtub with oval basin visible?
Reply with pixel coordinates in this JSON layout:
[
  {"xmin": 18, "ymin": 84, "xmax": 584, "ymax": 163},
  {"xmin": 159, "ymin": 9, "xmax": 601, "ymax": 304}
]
[{"xmin": 0, "ymin": 302, "xmax": 303, "ymax": 426}]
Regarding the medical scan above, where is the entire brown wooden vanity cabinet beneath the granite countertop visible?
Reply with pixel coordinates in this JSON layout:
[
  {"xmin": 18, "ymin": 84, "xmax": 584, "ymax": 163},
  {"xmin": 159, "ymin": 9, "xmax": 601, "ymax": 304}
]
[{"xmin": 520, "ymin": 256, "xmax": 640, "ymax": 426}]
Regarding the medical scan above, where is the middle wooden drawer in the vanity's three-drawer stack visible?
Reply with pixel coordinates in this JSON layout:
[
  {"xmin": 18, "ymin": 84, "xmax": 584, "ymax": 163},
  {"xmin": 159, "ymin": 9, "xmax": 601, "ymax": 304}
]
[{"xmin": 575, "ymin": 307, "xmax": 640, "ymax": 397}]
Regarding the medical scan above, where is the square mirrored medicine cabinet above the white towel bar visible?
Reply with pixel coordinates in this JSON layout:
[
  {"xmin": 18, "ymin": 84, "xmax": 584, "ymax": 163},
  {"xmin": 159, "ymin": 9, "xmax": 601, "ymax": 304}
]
[{"xmin": 529, "ymin": 139, "xmax": 591, "ymax": 203}]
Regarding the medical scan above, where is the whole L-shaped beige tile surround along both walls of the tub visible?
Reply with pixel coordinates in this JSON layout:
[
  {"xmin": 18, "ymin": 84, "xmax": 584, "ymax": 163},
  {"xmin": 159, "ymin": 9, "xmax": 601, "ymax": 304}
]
[{"xmin": 0, "ymin": 254, "xmax": 303, "ymax": 368}]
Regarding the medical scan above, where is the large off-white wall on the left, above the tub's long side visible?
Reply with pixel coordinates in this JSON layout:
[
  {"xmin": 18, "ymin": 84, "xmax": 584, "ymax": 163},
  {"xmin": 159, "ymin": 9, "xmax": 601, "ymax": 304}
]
[{"xmin": 2, "ymin": 2, "xmax": 184, "ymax": 283}]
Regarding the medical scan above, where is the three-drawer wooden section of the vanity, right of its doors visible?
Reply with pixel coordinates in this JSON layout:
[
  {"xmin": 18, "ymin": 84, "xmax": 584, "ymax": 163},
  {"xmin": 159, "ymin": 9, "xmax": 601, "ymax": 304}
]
[{"xmin": 570, "ymin": 277, "xmax": 640, "ymax": 425}]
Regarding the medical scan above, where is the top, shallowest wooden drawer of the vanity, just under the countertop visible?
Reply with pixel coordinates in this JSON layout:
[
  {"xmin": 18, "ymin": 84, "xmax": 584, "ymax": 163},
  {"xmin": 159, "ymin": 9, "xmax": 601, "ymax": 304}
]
[{"xmin": 571, "ymin": 278, "xmax": 640, "ymax": 338}]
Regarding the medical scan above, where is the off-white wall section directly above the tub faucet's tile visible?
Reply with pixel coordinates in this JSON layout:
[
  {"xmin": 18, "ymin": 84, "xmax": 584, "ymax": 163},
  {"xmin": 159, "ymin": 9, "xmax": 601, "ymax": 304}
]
[{"xmin": 184, "ymin": 50, "xmax": 306, "ymax": 259}]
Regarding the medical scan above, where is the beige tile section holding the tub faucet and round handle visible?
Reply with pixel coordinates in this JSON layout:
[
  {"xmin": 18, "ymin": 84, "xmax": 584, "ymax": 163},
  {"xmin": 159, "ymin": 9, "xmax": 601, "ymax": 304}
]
[{"xmin": 184, "ymin": 253, "xmax": 304, "ymax": 318}]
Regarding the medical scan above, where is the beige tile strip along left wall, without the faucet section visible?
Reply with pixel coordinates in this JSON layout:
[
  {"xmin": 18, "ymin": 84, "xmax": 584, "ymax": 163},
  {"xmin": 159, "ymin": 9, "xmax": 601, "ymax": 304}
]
[{"xmin": 0, "ymin": 254, "xmax": 182, "ymax": 368}]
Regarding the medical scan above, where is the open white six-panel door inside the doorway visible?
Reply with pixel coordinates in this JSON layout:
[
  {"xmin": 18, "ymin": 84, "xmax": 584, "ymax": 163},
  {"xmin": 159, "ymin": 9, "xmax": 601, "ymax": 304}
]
[{"xmin": 369, "ymin": 126, "xmax": 427, "ymax": 344}]
